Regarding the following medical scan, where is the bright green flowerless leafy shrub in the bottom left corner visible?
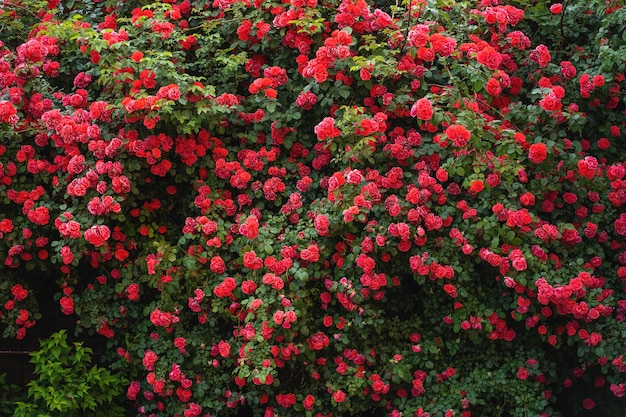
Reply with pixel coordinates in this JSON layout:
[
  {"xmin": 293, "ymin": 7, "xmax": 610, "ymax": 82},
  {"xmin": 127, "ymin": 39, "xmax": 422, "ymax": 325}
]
[{"xmin": 13, "ymin": 330, "xmax": 125, "ymax": 417}]
